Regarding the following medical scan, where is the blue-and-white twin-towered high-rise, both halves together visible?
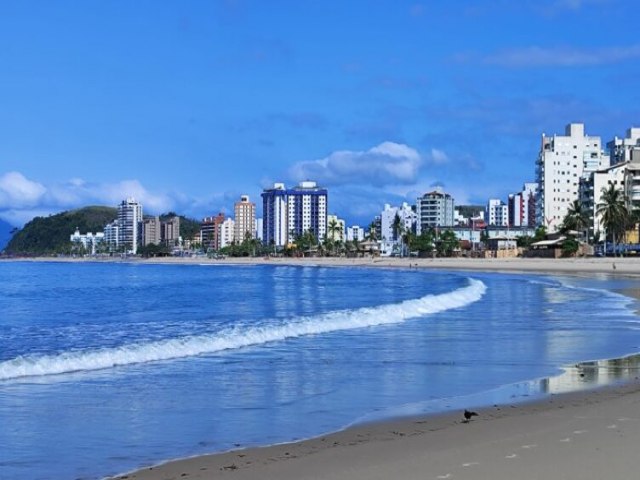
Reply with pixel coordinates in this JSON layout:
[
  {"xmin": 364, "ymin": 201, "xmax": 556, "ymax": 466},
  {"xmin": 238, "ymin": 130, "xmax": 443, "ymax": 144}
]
[{"xmin": 262, "ymin": 181, "xmax": 327, "ymax": 247}]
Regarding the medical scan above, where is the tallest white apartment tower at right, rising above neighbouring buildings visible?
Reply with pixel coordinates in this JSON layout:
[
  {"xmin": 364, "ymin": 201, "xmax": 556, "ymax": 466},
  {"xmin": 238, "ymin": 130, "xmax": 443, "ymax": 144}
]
[{"xmin": 536, "ymin": 123, "xmax": 609, "ymax": 233}]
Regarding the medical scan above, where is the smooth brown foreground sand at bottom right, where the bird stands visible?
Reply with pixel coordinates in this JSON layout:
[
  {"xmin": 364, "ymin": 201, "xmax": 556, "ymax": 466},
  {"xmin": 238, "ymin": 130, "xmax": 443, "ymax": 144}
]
[{"xmin": 107, "ymin": 364, "xmax": 640, "ymax": 480}]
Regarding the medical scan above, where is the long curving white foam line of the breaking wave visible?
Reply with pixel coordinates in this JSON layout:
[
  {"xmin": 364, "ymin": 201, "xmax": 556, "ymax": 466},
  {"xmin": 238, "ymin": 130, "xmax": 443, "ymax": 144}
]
[{"xmin": 0, "ymin": 279, "xmax": 487, "ymax": 380}]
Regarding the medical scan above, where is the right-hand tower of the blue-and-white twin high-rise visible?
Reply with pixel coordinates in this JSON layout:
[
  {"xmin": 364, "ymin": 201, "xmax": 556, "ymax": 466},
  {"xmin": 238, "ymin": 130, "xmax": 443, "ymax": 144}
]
[{"xmin": 287, "ymin": 181, "xmax": 327, "ymax": 241}]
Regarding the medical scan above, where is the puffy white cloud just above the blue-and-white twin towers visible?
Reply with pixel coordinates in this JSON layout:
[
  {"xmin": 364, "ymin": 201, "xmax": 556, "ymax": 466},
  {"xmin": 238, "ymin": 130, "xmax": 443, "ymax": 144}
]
[{"xmin": 289, "ymin": 142, "xmax": 423, "ymax": 187}]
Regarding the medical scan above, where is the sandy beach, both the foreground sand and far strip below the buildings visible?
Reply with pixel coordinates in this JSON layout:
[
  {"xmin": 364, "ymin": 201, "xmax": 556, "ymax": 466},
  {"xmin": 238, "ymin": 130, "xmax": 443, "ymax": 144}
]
[{"xmin": 91, "ymin": 258, "xmax": 640, "ymax": 480}]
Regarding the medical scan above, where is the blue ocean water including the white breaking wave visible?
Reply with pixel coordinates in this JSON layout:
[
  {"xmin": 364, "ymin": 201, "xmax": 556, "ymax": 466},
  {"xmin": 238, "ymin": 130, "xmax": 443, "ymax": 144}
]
[{"xmin": 0, "ymin": 262, "xmax": 640, "ymax": 480}]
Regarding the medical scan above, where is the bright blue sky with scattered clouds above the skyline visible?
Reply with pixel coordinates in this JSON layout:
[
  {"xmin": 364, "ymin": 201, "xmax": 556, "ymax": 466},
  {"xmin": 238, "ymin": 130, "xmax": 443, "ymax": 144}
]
[{"xmin": 0, "ymin": 0, "xmax": 640, "ymax": 226}]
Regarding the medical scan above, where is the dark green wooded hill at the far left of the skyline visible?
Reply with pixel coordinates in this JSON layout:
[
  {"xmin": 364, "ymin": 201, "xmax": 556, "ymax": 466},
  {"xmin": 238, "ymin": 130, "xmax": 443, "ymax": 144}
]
[{"xmin": 6, "ymin": 207, "xmax": 117, "ymax": 255}]
